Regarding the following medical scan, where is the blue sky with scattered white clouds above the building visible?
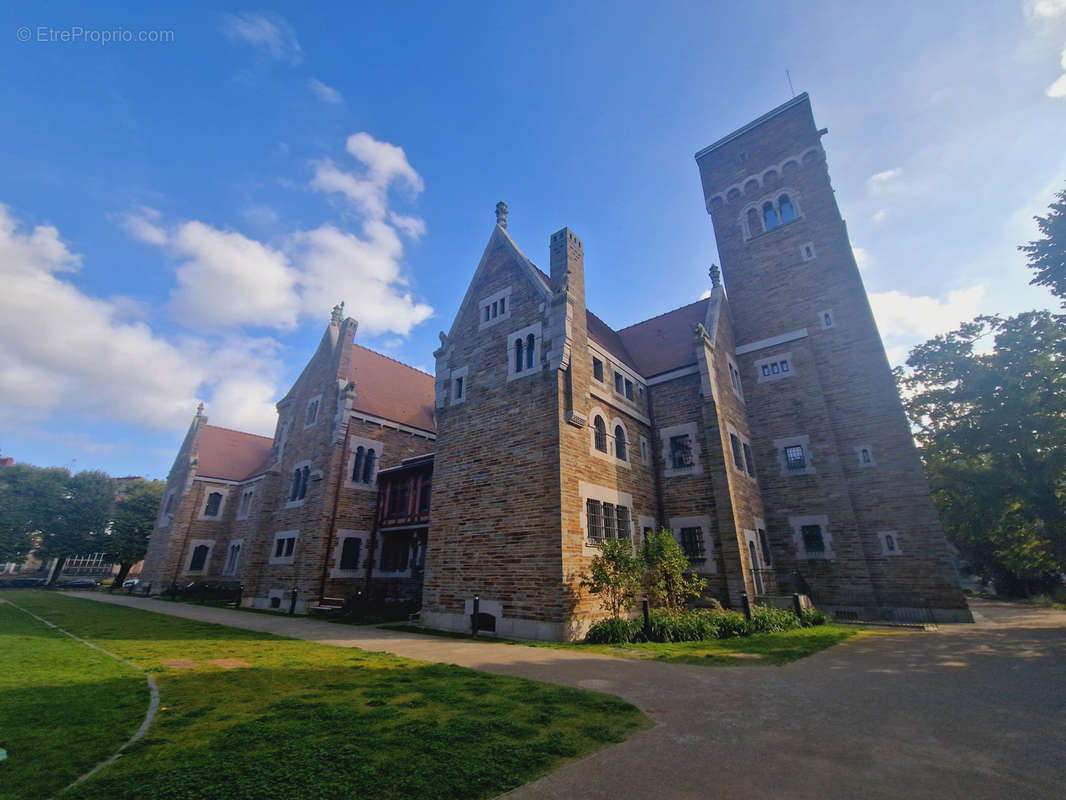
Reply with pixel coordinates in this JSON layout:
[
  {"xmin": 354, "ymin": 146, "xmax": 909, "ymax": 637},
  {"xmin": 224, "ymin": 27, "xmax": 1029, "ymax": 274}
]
[{"xmin": 0, "ymin": 0, "xmax": 1066, "ymax": 477}]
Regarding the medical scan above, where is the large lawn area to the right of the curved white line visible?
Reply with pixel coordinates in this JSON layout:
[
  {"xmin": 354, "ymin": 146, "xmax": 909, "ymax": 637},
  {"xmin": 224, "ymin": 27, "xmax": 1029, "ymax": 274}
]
[{"xmin": 0, "ymin": 591, "xmax": 648, "ymax": 800}]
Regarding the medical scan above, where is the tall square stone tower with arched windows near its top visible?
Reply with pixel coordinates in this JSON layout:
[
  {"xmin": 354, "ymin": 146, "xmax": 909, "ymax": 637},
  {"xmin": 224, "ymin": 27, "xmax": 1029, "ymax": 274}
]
[{"xmin": 696, "ymin": 94, "xmax": 970, "ymax": 621}]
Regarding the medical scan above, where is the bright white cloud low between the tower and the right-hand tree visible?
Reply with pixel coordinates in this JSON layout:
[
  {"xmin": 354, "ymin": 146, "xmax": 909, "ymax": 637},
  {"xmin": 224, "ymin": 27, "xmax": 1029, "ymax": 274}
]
[{"xmin": 870, "ymin": 284, "xmax": 985, "ymax": 365}]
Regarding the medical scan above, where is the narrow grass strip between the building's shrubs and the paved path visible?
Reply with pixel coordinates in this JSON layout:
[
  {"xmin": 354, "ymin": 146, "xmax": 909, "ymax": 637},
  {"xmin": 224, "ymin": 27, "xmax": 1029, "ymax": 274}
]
[{"xmin": 382, "ymin": 625, "xmax": 870, "ymax": 667}]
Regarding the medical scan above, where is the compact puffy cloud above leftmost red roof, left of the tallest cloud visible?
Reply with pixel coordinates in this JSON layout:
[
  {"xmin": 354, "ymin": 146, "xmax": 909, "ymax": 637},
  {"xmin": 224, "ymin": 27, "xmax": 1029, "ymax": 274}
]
[{"xmin": 171, "ymin": 221, "xmax": 300, "ymax": 329}]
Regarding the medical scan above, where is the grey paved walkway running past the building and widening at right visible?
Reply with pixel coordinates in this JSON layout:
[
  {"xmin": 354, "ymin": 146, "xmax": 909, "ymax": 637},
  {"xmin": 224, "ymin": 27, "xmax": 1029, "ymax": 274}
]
[{"xmin": 66, "ymin": 594, "xmax": 1066, "ymax": 800}]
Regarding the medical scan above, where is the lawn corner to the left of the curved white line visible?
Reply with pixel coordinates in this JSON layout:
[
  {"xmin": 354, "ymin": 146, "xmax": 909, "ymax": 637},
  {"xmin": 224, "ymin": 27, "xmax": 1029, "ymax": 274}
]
[{"xmin": 0, "ymin": 592, "xmax": 148, "ymax": 800}]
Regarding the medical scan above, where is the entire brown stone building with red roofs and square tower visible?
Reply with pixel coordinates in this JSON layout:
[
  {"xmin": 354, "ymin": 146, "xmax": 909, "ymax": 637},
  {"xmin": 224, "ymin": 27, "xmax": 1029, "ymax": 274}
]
[{"xmin": 137, "ymin": 94, "xmax": 970, "ymax": 639}]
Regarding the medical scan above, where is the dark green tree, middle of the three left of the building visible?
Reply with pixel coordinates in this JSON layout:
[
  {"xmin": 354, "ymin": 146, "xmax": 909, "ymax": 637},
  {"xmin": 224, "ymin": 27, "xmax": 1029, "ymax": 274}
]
[{"xmin": 34, "ymin": 469, "xmax": 115, "ymax": 582}]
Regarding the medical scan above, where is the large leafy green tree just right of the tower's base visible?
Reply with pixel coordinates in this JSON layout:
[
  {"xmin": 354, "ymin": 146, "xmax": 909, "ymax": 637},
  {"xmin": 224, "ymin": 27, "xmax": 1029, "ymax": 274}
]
[{"xmin": 901, "ymin": 311, "xmax": 1066, "ymax": 587}]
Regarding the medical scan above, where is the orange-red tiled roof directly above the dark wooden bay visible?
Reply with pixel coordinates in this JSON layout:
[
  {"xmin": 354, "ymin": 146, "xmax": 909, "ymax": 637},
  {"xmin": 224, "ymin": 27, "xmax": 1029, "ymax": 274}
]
[{"xmin": 348, "ymin": 345, "xmax": 437, "ymax": 431}]
